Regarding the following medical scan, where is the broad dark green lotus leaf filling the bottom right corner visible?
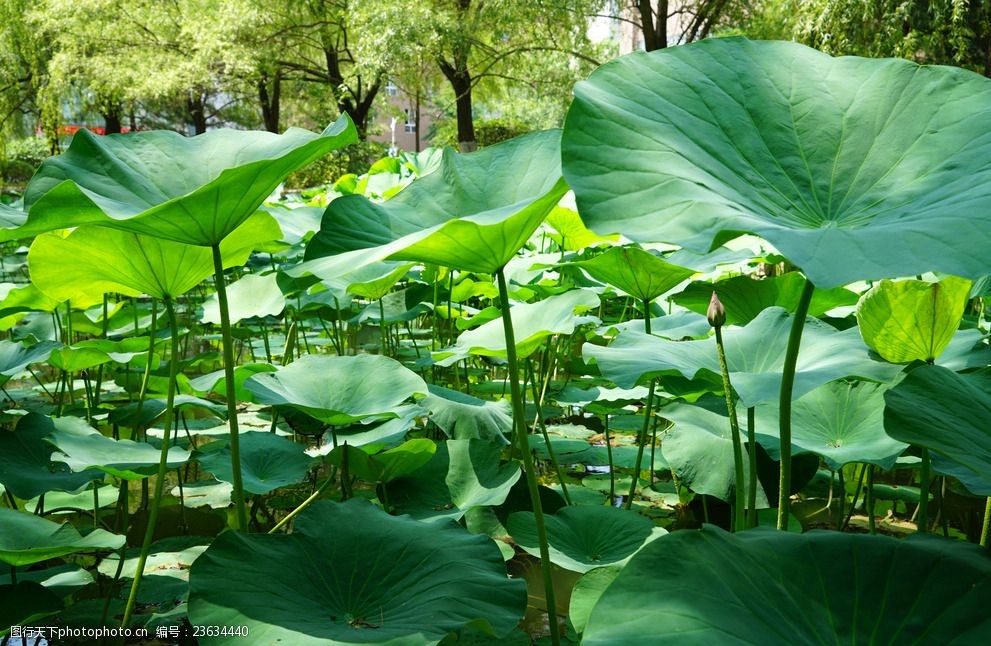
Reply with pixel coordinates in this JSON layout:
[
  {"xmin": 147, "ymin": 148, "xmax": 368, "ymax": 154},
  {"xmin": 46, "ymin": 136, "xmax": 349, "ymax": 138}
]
[{"xmin": 582, "ymin": 525, "xmax": 991, "ymax": 645}]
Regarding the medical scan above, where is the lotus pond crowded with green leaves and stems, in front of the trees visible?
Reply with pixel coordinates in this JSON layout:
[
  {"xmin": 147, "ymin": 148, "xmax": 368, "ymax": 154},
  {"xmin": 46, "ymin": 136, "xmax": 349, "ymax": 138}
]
[{"xmin": 0, "ymin": 38, "xmax": 991, "ymax": 645}]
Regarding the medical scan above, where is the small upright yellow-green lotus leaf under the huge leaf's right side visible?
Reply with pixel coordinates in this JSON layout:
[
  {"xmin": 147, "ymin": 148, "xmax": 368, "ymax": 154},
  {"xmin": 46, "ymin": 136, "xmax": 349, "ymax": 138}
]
[{"xmin": 857, "ymin": 276, "xmax": 970, "ymax": 363}]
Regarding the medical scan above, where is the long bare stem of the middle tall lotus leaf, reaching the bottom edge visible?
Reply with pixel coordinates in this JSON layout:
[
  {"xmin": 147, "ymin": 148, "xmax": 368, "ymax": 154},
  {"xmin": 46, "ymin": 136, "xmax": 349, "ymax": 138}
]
[{"xmin": 496, "ymin": 269, "xmax": 561, "ymax": 646}]
